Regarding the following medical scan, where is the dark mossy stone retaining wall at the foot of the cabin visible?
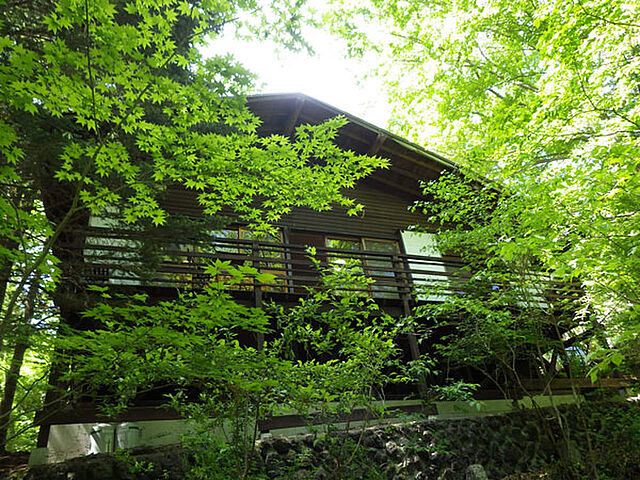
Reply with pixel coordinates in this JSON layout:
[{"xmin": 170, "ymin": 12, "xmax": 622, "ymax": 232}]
[{"xmin": 15, "ymin": 403, "xmax": 640, "ymax": 480}]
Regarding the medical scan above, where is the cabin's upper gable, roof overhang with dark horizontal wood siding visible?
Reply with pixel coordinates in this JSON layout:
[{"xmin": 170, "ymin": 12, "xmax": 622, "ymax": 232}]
[{"xmin": 160, "ymin": 94, "xmax": 457, "ymax": 240}]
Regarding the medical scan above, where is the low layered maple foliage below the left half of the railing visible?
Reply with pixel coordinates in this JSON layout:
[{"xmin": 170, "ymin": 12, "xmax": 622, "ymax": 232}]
[{"xmin": 57, "ymin": 262, "xmax": 269, "ymax": 408}]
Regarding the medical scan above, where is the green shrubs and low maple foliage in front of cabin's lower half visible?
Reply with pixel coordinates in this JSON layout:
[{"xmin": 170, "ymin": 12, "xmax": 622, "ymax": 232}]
[{"xmin": 57, "ymin": 261, "xmax": 399, "ymax": 479}]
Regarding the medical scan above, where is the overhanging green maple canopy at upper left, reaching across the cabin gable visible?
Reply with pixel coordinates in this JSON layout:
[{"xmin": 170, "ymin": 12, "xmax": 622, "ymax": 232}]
[{"xmin": 0, "ymin": 0, "xmax": 383, "ymax": 229}]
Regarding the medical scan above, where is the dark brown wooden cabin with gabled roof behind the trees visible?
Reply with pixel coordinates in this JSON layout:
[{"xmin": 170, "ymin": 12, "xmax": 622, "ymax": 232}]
[{"xmin": 32, "ymin": 94, "xmax": 592, "ymax": 461}]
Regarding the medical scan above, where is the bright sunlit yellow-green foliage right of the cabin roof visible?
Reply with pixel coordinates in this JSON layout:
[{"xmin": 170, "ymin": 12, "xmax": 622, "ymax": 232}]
[{"xmin": 332, "ymin": 0, "xmax": 640, "ymax": 374}]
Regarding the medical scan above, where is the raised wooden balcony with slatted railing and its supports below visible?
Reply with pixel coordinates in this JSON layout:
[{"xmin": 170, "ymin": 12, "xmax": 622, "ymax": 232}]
[{"xmin": 45, "ymin": 227, "xmax": 596, "ymax": 414}]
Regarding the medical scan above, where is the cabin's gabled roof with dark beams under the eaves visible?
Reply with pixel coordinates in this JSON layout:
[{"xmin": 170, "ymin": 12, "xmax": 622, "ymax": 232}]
[{"xmin": 247, "ymin": 93, "xmax": 458, "ymax": 199}]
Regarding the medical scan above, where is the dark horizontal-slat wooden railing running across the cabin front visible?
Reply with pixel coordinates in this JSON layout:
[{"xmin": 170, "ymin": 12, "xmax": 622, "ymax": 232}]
[{"xmin": 58, "ymin": 228, "xmax": 579, "ymax": 303}]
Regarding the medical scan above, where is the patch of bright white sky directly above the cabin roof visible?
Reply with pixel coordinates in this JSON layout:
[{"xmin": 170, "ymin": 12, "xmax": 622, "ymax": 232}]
[{"xmin": 203, "ymin": 25, "xmax": 391, "ymax": 128}]
